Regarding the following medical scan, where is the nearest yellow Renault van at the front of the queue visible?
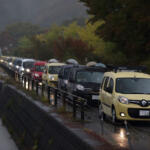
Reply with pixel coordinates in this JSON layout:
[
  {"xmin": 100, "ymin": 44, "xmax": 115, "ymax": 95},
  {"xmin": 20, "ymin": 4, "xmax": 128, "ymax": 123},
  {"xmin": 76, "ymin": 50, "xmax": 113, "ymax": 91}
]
[{"xmin": 99, "ymin": 71, "xmax": 150, "ymax": 123}]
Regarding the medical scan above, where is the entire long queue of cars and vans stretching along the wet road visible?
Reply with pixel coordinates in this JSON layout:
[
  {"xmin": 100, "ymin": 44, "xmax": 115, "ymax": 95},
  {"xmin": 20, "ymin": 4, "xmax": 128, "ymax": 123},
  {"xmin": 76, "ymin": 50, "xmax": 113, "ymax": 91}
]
[{"xmin": 0, "ymin": 56, "xmax": 150, "ymax": 123}]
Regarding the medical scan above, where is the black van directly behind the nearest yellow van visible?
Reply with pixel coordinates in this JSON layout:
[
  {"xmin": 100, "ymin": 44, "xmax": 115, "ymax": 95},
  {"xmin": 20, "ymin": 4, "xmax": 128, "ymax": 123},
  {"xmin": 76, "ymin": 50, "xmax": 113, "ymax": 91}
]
[{"xmin": 67, "ymin": 67, "xmax": 106, "ymax": 106}]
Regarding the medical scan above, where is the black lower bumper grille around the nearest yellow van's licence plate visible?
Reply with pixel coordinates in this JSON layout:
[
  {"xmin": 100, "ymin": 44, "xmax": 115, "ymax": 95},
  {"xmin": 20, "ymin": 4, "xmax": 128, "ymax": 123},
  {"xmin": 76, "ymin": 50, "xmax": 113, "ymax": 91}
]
[{"xmin": 128, "ymin": 108, "xmax": 150, "ymax": 119}]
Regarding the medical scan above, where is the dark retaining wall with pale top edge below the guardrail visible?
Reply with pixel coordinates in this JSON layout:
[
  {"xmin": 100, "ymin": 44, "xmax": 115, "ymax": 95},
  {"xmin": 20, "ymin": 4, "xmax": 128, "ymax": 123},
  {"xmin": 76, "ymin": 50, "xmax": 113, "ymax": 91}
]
[{"xmin": 0, "ymin": 82, "xmax": 103, "ymax": 150}]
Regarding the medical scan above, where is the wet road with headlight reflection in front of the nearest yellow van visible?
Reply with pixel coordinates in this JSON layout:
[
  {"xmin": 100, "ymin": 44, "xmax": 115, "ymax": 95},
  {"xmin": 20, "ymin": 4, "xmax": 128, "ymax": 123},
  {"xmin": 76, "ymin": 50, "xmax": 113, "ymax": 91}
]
[{"xmin": 84, "ymin": 108, "xmax": 150, "ymax": 150}]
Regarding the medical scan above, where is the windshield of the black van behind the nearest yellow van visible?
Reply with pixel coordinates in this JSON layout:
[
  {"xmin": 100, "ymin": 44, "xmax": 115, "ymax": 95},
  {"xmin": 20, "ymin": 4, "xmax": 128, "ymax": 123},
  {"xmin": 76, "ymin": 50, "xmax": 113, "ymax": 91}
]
[{"xmin": 76, "ymin": 71, "xmax": 104, "ymax": 84}]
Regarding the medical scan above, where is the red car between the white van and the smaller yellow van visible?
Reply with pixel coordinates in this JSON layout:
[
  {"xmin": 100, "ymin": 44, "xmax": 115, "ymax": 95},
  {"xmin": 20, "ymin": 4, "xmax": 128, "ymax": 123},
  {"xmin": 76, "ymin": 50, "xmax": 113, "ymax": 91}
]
[{"xmin": 31, "ymin": 61, "xmax": 46, "ymax": 82}]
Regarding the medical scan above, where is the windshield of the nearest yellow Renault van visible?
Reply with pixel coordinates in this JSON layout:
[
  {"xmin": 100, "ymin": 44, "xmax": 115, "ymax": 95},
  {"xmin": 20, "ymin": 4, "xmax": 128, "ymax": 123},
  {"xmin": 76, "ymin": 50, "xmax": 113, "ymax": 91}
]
[{"xmin": 116, "ymin": 78, "xmax": 150, "ymax": 94}]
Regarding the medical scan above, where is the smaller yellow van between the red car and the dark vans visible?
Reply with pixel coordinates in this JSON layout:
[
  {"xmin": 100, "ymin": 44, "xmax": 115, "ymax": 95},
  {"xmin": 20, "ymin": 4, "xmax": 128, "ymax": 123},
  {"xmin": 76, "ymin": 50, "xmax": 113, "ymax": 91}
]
[{"xmin": 42, "ymin": 63, "xmax": 65, "ymax": 87}]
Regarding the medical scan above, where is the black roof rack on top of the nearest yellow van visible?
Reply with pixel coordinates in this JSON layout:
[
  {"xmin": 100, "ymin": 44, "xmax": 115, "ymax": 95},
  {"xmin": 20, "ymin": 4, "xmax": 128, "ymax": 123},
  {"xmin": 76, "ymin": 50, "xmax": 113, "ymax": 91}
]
[{"xmin": 107, "ymin": 65, "xmax": 147, "ymax": 72}]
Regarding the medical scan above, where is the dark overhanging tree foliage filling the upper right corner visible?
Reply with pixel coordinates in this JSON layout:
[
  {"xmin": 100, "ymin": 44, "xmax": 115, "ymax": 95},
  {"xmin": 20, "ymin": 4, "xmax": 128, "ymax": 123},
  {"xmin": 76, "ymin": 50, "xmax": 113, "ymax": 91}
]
[{"xmin": 80, "ymin": 0, "xmax": 150, "ymax": 64}]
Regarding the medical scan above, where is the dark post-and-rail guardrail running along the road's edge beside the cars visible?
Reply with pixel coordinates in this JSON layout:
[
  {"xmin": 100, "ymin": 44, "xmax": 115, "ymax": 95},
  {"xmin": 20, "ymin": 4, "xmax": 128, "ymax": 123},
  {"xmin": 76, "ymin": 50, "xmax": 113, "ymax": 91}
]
[{"xmin": 1, "ymin": 64, "xmax": 86, "ymax": 121}]
